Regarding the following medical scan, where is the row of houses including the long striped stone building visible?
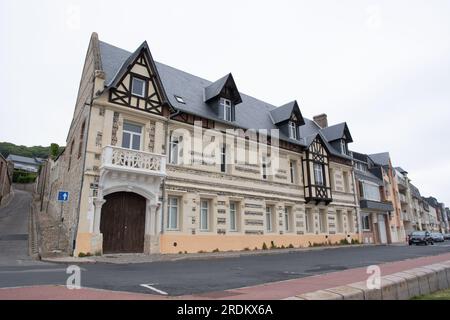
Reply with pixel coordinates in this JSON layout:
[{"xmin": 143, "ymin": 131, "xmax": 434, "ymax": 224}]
[{"xmin": 37, "ymin": 33, "xmax": 448, "ymax": 255}]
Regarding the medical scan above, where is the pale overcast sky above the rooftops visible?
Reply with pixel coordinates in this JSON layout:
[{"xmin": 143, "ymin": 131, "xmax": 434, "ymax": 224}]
[{"xmin": 0, "ymin": 0, "xmax": 450, "ymax": 204}]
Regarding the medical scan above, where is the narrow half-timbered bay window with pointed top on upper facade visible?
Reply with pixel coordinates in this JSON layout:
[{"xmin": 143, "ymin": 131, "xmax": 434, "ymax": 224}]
[{"xmin": 303, "ymin": 134, "xmax": 332, "ymax": 204}]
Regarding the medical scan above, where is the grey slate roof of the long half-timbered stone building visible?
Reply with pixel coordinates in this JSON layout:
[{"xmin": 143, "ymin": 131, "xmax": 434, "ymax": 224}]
[{"xmin": 99, "ymin": 41, "xmax": 352, "ymax": 160}]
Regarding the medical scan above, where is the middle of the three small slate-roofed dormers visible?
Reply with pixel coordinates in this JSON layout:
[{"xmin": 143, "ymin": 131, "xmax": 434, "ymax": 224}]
[{"xmin": 270, "ymin": 100, "xmax": 305, "ymax": 140}]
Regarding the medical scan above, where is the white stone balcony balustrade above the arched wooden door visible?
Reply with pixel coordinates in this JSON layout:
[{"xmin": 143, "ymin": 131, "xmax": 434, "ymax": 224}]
[{"xmin": 100, "ymin": 146, "xmax": 166, "ymax": 177}]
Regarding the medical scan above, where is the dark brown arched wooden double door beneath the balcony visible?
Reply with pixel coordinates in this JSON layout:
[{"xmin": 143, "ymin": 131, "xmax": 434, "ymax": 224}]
[{"xmin": 100, "ymin": 192, "xmax": 146, "ymax": 253}]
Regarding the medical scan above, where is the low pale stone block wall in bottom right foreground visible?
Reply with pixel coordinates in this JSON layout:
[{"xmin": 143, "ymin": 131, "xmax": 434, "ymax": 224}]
[{"xmin": 284, "ymin": 260, "xmax": 450, "ymax": 300}]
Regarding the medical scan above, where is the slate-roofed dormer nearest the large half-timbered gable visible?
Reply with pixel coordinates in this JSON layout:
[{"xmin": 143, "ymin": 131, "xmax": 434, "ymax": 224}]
[{"xmin": 204, "ymin": 73, "xmax": 242, "ymax": 122}]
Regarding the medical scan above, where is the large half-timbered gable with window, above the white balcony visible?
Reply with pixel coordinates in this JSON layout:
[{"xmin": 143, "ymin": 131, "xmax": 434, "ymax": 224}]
[{"xmin": 109, "ymin": 42, "xmax": 167, "ymax": 115}]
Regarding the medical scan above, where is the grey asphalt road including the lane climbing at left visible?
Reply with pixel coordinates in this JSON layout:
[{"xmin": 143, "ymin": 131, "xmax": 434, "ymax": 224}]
[{"xmin": 0, "ymin": 192, "xmax": 450, "ymax": 295}]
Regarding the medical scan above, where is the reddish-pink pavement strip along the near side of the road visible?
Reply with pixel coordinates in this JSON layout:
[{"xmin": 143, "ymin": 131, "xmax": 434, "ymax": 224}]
[{"xmin": 0, "ymin": 253, "xmax": 450, "ymax": 300}]
